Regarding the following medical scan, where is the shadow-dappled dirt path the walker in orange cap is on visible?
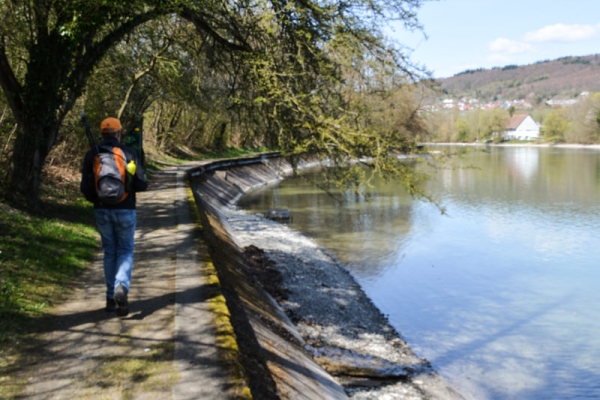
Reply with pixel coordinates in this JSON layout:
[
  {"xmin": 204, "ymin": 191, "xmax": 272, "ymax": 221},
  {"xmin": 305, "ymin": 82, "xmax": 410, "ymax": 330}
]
[{"xmin": 19, "ymin": 166, "xmax": 231, "ymax": 400}]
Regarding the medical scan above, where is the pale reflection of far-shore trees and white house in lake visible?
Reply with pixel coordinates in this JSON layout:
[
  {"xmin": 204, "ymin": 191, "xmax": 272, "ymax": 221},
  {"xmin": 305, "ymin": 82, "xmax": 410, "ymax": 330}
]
[{"xmin": 431, "ymin": 148, "xmax": 600, "ymax": 208}]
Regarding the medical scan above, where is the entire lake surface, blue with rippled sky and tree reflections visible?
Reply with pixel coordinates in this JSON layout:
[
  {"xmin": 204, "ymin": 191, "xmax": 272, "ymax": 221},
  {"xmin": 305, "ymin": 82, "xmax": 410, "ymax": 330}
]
[{"xmin": 240, "ymin": 147, "xmax": 600, "ymax": 400}]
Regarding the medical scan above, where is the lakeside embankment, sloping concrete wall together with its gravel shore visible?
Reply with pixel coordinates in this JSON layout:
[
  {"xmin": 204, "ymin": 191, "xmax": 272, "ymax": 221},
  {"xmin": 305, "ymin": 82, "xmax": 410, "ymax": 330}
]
[{"xmin": 188, "ymin": 154, "xmax": 462, "ymax": 399}]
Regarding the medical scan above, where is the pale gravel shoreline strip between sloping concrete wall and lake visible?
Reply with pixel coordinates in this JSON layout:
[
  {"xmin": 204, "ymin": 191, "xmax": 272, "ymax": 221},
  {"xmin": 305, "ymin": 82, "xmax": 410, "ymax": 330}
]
[{"xmin": 192, "ymin": 160, "xmax": 463, "ymax": 400}]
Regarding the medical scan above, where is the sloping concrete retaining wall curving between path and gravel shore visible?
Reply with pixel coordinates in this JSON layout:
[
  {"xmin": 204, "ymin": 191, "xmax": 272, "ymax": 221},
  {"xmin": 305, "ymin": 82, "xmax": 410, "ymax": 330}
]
[{"xmin": 188, "ymin": 153, "xmax": 347, "ymax": 400}]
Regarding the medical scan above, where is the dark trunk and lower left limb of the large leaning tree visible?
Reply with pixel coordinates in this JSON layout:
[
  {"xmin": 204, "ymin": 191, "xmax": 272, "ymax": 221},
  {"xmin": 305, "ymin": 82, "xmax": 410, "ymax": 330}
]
[{"xmin": 0, "ymin": 0, "xmax": 178, "ymax": 203}]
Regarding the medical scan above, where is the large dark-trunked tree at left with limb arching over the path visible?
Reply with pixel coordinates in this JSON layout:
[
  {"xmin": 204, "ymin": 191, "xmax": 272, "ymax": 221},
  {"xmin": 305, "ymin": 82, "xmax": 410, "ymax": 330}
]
[{"xmin": 0, "ymin": 0, "xmax": 432, "ymax": 203}]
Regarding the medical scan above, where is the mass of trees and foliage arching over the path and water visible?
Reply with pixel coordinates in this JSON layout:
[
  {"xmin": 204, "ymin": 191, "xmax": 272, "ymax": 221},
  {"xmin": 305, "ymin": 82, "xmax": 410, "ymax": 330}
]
[{"xmin": 0, "ymin": 0, "xmax": 432, "ymax": 206}]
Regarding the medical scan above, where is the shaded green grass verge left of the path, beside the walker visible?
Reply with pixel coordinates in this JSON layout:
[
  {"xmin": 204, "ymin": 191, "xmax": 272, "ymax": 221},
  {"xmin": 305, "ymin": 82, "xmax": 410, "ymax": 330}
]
[{"xmin": 0, "ymin": 200, "xmax": 97, "ymax": 340}]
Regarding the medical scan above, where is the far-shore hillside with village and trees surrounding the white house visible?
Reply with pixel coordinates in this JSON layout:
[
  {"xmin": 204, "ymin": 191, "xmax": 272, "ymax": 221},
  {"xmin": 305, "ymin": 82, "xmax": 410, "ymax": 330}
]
[{"xmin": 423, "ymin": 54, "xmax": 600, "ymax": 144}]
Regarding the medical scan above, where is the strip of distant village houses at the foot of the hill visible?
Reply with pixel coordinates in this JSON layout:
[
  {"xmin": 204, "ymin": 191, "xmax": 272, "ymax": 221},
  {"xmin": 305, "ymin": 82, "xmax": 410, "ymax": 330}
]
[{"xmin": 422, "ymin": 92, "xmax": 589, "ymax": 111}]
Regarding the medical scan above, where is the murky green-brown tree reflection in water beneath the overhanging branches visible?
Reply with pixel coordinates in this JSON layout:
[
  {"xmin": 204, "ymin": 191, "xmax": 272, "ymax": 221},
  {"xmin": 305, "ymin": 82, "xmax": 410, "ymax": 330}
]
[{"xmin": 239, "ymin": 178, "xmax": 412, "ymax": 274}]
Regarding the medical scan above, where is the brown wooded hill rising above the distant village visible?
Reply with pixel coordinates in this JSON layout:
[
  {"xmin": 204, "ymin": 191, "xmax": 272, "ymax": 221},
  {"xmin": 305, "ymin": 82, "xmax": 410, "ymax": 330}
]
[{"xmin": 438, "ymin": 54, "xmax": 600, "ymax": 105}]
